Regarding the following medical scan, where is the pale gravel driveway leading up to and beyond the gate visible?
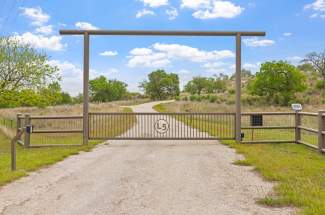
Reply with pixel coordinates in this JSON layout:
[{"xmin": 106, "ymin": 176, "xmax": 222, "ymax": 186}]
[{"xmin": 0, "ymin": 103, "xmax": 292, "ymax": 215}]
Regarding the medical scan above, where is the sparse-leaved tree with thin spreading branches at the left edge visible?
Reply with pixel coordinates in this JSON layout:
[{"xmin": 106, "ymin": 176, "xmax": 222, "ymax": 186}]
[{"xmin": 0, "ymin": 38, "xmax": 60, "ymax": 95}]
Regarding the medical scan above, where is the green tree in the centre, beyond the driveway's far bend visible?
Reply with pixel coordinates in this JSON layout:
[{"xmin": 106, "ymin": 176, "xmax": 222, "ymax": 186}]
[{"xmin": 140, "ymin": 70, "xmax": 180, "ymax": 100}]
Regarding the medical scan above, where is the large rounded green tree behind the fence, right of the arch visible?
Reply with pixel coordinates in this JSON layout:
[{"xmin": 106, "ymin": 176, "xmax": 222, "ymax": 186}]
[{"xmin": 248, "ymin": 61, "xmax": 306, "ymax": 105}]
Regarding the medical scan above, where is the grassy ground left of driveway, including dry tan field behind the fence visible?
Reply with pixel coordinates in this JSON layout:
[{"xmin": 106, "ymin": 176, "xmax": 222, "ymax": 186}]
[{"xmin": 0, "ymin": 103, "xmax": 135, "ymax": 185}]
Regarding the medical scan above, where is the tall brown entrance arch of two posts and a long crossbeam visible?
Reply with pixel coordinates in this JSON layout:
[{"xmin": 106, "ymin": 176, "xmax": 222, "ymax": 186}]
[{"xmin": 60, "ymin": 30, "xmax": 266, "ymax": 144}]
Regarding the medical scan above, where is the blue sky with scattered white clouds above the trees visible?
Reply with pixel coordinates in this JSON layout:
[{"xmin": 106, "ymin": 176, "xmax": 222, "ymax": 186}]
[{"xmin": 0, "ymin": 0, "xmax": 325, "ymax": 95}]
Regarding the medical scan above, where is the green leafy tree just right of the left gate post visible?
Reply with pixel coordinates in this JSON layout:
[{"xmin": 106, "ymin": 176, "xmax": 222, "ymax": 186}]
[{"xmin": 89, "ymin": 76, "xmax": 127, "ymax": 102}]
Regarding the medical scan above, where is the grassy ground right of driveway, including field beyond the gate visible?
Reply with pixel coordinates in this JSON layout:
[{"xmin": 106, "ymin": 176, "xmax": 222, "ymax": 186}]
[{"xmin": 155, "ymin": 102, "xmax": 325, "ymax": 215}]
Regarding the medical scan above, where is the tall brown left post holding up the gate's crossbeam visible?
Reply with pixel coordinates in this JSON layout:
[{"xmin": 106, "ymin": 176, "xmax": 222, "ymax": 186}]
[{"xmin": 83, "ymin": 32, "xmax": 89, "ymax": 144}]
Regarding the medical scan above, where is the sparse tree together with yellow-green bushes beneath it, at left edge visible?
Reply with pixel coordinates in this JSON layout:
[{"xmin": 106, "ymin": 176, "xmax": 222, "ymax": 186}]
[{"xmin": 0, "ymin": 38, "xmax": 67, "ymax": 108}]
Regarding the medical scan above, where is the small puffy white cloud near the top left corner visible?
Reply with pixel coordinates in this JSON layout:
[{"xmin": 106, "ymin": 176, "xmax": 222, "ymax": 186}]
[{"xmin": 20, "ymin": 7, "xmax": 50, "ymax": 26}]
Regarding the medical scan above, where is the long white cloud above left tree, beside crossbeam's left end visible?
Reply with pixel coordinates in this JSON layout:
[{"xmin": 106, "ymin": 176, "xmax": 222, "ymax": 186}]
[{"xmin": 12, "ymin": 32, "xmax": 66, "ymax": 51}]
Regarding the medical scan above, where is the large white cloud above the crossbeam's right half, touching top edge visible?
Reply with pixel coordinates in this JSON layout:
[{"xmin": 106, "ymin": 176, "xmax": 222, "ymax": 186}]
[{"xmin": 181, "ymin": 0, "xmax": 244, "ymax": 19}]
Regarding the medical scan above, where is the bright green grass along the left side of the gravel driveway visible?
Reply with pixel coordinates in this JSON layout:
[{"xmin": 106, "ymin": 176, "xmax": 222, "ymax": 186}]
[{"xmin": 0, "ymin": 109, "xmax": 135, "ymax": 186}]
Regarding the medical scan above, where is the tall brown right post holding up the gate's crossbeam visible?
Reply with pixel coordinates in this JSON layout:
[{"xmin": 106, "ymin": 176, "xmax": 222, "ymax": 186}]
[{"xmin": 236, "ymin": 33, "xmax": 241, "ymax": 143}]
